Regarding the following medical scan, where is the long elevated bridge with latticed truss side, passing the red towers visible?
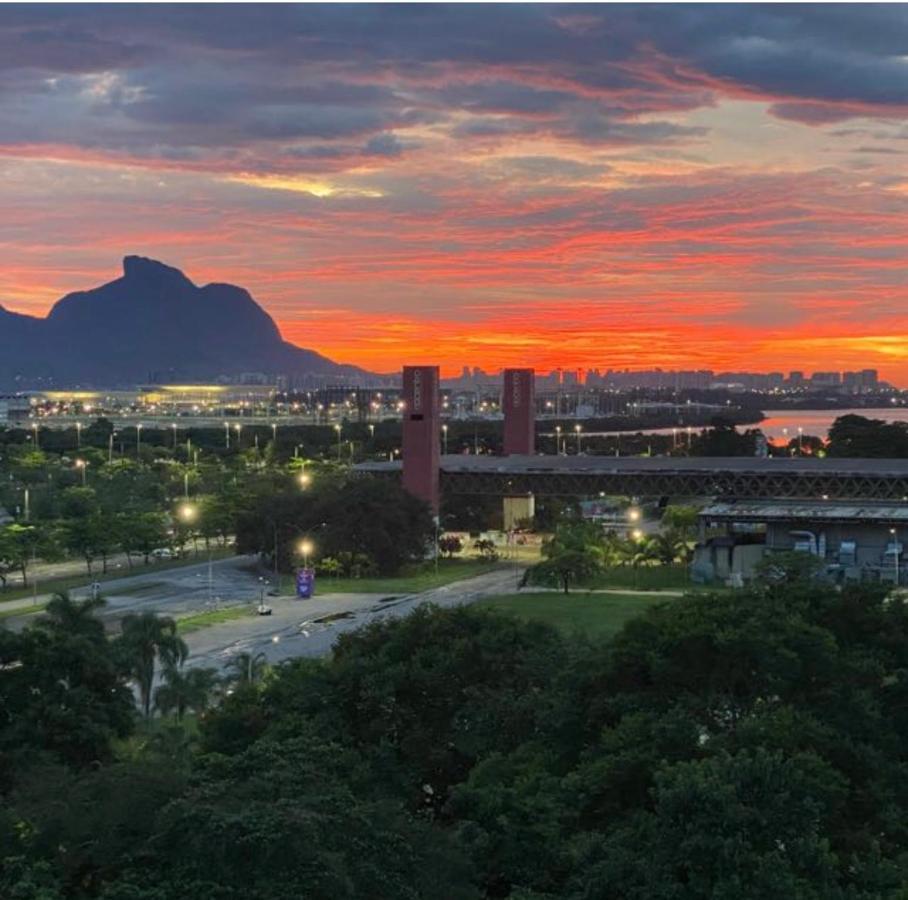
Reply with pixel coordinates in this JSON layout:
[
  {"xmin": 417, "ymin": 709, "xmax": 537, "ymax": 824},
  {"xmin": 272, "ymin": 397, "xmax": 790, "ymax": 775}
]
[{"xmin": 357, "ymin": 455, "xmax": 908, "ymax": 502}]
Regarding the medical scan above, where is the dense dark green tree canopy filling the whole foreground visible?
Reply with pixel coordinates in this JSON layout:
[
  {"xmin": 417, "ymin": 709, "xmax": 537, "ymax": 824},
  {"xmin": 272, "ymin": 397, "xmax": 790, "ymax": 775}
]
[{"xmin": 0, "ymin": 557, "xmax": 908, "ymax": 900}]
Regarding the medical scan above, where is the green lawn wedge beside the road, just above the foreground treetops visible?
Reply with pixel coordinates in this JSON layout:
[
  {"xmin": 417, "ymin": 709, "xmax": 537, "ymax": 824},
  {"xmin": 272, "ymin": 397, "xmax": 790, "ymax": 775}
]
[{"xmin": 476, "ymin": 591, "xmax": 672, "ymax": 638}]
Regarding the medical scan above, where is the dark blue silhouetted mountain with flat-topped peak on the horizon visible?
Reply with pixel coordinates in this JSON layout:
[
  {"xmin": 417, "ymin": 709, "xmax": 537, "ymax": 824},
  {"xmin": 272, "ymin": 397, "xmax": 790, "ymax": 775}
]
[{"xmin": 0, "ymin": 256, "xmax": 371, "ymax": 389}]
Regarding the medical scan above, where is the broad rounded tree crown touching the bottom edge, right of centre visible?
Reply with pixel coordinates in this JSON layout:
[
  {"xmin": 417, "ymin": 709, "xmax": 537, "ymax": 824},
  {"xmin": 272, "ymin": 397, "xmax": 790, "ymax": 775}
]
[{"xmin": 569, "ymin": 749, "xmax": 845, "ymax": 900}]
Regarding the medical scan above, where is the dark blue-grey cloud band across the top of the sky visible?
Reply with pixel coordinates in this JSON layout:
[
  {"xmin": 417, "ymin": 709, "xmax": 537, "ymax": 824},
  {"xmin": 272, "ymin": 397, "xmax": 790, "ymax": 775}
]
[{"xmin": 0, "ymin": 4, "xmax": 908, "ymax": 158}]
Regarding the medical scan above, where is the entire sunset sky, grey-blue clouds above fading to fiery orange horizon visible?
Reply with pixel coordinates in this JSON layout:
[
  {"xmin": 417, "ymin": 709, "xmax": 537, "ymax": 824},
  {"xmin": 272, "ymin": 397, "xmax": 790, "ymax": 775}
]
[{"xmin": 0, "ymin": 4, "xmax": 908, "ymax": 386}]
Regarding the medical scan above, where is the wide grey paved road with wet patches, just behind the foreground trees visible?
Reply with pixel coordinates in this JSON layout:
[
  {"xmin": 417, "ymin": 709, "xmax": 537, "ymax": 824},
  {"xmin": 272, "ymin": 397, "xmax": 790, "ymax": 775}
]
[{"xmin": 186, "ymin": 567, "xmax": 522, "ymax": 669}]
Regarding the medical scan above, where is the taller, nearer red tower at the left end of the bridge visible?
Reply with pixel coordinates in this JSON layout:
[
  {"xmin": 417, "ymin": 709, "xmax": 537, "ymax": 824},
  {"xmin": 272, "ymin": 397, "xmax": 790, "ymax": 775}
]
[{"xmin": 403, "ymin": 366, "xmax": 441, "ymax": 513}]
